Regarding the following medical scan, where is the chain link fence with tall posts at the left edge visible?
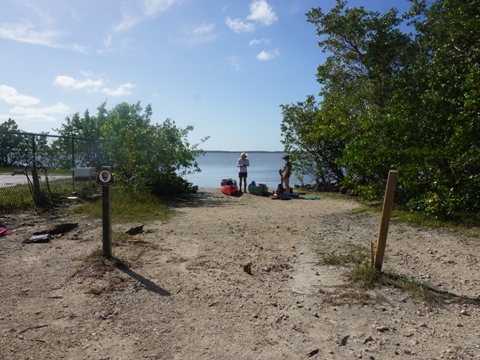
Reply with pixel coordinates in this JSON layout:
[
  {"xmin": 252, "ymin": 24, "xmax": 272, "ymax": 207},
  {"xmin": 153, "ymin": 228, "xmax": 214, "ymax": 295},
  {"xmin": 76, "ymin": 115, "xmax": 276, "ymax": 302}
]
[{"xmin": 0, "ymin": 131, "xmax": 106, "ymax": 213}]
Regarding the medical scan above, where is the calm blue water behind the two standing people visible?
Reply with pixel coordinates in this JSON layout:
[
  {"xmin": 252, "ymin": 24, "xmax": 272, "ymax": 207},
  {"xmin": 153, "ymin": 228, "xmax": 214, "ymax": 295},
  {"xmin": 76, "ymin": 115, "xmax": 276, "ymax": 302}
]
[{"xmin": 186, "ymin": 152, "xmax": 308, "ymax": 188}]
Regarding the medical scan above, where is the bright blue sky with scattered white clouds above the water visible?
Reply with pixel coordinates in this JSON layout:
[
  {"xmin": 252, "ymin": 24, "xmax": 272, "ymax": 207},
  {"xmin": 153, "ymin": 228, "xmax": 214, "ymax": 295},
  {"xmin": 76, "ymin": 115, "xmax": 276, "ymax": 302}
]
[{"xmin": 0, "ymin": 0, "xmax": 409, "ymax": 151}]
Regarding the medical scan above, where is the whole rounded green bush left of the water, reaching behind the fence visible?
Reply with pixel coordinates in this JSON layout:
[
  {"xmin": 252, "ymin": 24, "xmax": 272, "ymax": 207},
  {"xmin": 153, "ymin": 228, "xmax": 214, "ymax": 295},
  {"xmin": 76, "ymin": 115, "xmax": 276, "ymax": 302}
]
[{"xmin": 52, "ymin": 102, "xmax": 207, "ymax": 194}]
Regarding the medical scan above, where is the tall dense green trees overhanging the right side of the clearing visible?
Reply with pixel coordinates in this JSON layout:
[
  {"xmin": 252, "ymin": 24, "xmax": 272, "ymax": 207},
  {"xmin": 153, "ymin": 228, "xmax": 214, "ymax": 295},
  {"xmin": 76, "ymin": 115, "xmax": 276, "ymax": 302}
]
[{"xmin": 282, "ymin": 0, "xmax": 480, "ymax": 218}]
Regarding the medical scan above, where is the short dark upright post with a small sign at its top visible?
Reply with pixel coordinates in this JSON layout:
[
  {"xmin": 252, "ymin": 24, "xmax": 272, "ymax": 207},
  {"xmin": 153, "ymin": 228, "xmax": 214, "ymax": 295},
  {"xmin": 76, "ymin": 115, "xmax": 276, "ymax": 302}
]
[{"xmin": 97, "ymin": 166, "xmax": 115, "ymax": 258}]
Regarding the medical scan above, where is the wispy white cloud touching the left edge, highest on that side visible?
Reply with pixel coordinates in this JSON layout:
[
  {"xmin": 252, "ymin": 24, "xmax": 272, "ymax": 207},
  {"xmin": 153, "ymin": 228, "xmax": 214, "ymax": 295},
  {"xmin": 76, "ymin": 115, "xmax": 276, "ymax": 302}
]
[{"xmin": 0, "ymin": 24, "xmax": 60, "ymax": 48}]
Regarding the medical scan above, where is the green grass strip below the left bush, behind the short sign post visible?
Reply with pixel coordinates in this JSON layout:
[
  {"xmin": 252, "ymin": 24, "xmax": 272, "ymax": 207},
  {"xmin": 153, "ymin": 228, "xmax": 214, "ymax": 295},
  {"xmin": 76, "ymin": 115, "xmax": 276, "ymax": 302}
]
[{"xmin": 76, "ymin": 189, "xmax": 174, "ymax": 224}]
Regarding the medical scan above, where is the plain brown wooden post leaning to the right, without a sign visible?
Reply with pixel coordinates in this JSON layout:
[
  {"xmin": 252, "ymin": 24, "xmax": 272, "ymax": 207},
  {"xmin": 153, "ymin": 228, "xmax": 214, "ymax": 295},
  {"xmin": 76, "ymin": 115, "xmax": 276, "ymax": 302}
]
[{"xmin": 375, "ymin": 170, "xmax": 398, "ymax": 271}]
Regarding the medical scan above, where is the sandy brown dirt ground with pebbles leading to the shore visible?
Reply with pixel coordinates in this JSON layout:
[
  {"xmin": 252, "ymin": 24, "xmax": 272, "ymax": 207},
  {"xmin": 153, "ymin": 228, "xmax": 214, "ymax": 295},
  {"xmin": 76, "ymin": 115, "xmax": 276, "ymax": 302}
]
[{"xmin": 0, "ymin": 189, "xmax": 480, "ymax": 360}]
